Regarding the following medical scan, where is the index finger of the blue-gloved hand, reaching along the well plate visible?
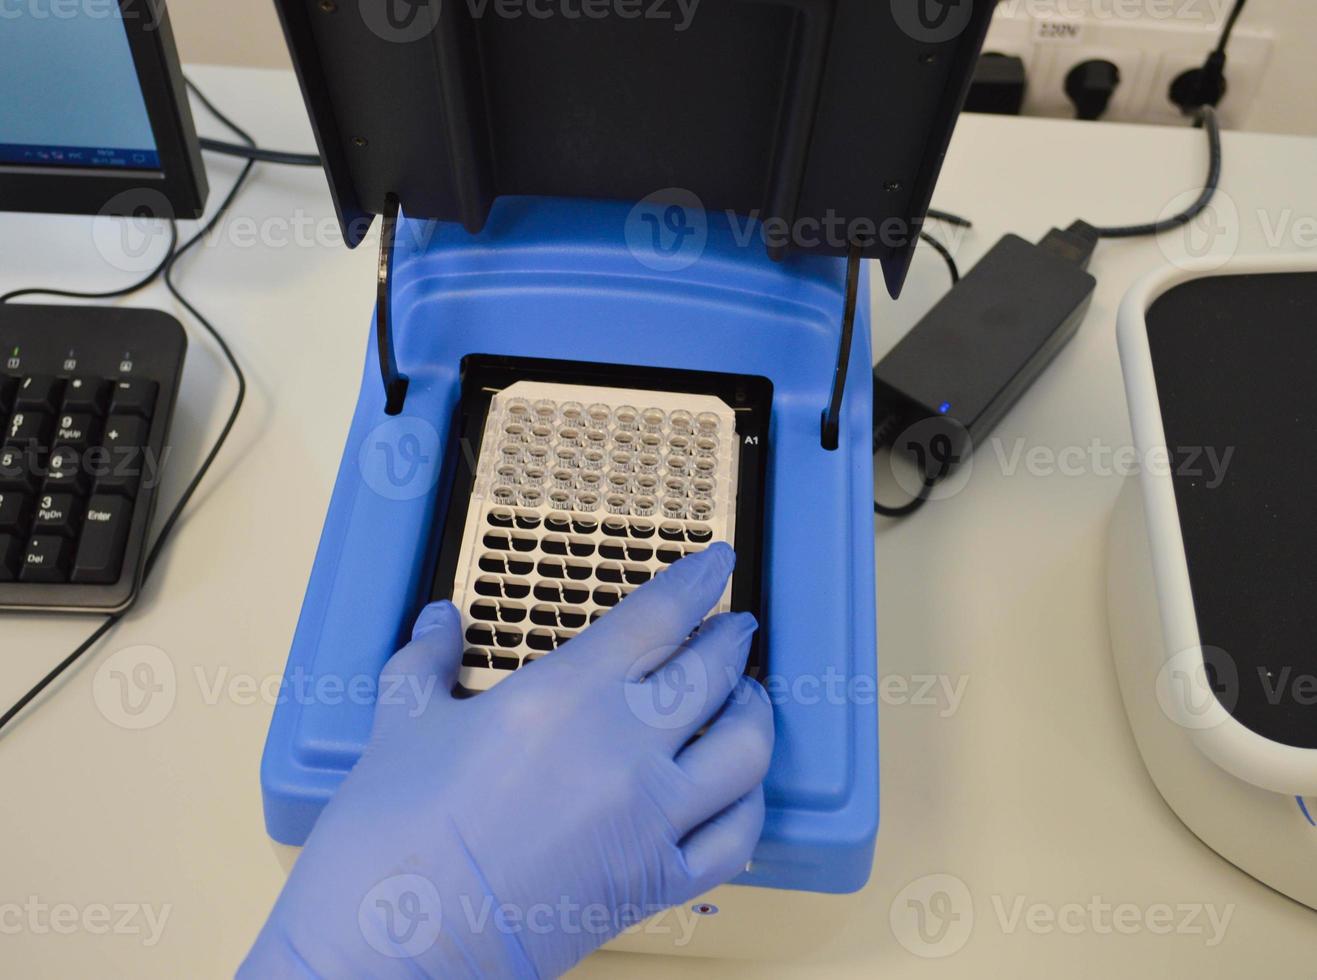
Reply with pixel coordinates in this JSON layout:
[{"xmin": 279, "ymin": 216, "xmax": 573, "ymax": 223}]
[{"xmin": 557, "ymin": 541, "xmax": 736, "ymax": 678}]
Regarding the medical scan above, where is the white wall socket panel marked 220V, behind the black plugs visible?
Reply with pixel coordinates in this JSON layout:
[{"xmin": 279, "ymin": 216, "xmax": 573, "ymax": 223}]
[{"xmin": 984, "ymin": 0, "xmax": 1272, "ymax": 126}]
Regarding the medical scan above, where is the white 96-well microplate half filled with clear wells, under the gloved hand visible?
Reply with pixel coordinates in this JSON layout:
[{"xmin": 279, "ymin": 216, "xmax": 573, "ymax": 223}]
[{"xmin": 453, "ymin": 381, "xmax": 739, "ymax": 690}]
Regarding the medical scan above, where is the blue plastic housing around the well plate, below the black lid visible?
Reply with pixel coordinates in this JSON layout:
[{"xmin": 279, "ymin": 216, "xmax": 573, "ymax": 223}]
[{"xmin": 261, "ymin": 198, "xmax": 878, "ymax": 893}]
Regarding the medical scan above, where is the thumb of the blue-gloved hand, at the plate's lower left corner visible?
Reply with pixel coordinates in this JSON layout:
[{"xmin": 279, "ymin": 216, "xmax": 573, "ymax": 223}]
[{"xmin": 375, "ymin": 602, "xmax": 462, "ymax": 723}]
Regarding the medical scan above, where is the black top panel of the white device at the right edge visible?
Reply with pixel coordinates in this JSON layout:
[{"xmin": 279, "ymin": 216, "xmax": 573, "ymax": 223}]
[{"xmin": 1147, "ymin": 273, "xmax": 1317, "ymax": 748}]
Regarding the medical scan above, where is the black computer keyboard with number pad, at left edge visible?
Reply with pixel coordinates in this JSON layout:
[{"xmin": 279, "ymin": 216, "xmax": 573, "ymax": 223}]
[{"xmin": 0, "ymin": 303, "xmax": 187, "ymax": 613}]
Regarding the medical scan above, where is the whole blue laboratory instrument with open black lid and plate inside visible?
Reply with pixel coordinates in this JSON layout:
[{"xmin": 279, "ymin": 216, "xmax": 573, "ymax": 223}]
[{"xmin": 262, "ymin": 0, "xmax": 993, "ymax": 952}]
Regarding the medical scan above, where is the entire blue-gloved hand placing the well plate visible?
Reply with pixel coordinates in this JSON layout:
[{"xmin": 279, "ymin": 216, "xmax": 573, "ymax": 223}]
[{"xmin": 241, "ymin": 544, "xmax": 773, "ymax": 977}]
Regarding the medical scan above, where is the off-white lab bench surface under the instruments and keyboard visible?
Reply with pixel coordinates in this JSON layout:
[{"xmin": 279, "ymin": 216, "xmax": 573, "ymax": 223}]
[{"xmin": 0, "ymin": 67, "xmax": 1317, "ymax": 979}]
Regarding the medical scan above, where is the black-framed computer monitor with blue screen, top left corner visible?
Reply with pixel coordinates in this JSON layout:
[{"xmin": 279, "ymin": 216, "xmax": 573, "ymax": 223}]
[{"xmin": 0, "ymin": 0, "xmax": 207, "ymax": 217}]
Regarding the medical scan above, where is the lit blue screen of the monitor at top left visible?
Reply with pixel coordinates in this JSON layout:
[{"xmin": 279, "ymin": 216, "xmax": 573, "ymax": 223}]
[{"xmin": 0, "ymin": 0, "xmax": 161, "ymax": 170}]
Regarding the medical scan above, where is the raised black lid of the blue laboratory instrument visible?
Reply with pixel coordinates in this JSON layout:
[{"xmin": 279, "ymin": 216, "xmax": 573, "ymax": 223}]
[{"xmin": 269, "ymin": 0, "xmax": 994, "ymax": 294}]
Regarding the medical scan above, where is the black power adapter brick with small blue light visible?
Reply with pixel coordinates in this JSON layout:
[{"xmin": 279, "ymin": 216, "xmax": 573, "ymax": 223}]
[{"xmin": 873, "ymin": 221, "xmax": 1098, "ymax": 490}]
